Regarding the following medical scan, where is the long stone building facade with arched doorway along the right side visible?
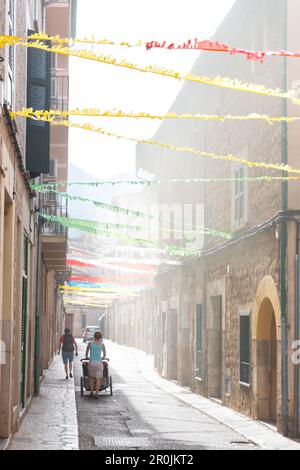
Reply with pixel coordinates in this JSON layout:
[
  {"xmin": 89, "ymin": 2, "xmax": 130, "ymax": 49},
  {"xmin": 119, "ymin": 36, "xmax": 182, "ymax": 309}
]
[{"xmin": 107, "ymin": 0, "xmax": 300, "ymax": 435}]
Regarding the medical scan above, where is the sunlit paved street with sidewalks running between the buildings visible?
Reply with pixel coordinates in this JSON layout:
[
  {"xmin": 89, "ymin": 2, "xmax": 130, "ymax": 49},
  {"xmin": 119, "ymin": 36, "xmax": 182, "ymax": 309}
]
[{"xmin": 10, "ymin": 340, "xmax": 300, "ymax": 450}]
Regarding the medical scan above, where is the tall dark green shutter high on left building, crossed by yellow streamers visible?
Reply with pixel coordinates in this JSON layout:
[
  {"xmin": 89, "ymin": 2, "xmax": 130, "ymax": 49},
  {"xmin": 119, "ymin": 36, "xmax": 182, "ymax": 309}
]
[{"xmin": 26, "ymin": 31, "xmax": 51, "ymax": 178}]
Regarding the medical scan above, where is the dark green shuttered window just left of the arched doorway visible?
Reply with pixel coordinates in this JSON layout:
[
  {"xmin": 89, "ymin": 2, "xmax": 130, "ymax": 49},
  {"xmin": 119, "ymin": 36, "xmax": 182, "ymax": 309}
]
[{"xmin": 240, "ymin": 311, "xmax": 250, "ymax": 385}]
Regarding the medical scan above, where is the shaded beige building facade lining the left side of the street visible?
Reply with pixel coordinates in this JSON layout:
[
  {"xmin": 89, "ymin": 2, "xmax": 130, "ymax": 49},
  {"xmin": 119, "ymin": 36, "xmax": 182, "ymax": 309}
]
[{"xmin": 0, "ymin": 0, "xmax": 74, "ymax": 444}]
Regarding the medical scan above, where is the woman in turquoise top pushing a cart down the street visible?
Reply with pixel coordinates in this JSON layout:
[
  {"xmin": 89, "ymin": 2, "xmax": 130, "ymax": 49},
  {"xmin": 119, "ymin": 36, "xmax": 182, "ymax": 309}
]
[{"xmin": 85, "ymin": 331, "xmax": 106, "ymax": 400}]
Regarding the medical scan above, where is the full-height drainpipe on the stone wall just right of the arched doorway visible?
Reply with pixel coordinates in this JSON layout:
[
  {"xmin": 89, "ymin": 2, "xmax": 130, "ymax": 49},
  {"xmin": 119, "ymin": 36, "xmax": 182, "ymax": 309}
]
[{"xmin": 280, "ymin": 0, "xmax": 288, "ymax": 436}]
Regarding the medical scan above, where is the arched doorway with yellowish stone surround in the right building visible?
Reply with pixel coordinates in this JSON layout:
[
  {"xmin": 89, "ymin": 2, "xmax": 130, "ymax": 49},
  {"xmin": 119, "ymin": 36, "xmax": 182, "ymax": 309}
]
[{"xmin": 253, "ymin": 277, "xmax": 281, "ymax": 425}]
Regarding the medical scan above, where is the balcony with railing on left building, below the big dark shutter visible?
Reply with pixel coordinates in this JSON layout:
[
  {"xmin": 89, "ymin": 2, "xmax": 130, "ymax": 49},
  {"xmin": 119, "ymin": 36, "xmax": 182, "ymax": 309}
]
[{"xmin": 42, "ymin": 193, "xmax": 68, "ymax": 272}]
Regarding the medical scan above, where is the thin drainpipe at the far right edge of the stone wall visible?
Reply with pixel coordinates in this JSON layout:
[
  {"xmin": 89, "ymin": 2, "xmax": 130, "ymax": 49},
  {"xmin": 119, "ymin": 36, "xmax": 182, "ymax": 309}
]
[{"xmin": 294, "ymin": 221, "xmax": 300, "ymax": 438}]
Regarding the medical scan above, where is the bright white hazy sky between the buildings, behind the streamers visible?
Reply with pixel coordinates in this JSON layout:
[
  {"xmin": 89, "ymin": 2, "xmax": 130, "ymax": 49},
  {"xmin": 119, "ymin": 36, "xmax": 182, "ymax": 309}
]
[{"xmin": 70, "ymin": 0, "xmax": 234, "ymax": 179}]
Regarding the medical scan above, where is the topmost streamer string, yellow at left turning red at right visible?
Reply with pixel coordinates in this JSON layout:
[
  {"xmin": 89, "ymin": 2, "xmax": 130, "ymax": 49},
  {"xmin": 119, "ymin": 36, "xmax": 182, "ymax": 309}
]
[{"xmin": 0, "ymin": 33, "xmax": 300, "ymax": 63}]
